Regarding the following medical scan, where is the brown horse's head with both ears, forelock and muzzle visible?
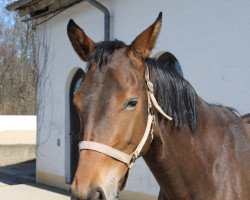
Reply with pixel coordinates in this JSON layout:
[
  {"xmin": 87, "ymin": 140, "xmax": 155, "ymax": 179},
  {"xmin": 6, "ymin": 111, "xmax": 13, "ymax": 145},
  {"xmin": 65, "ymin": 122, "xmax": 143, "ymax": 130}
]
[{"xmin": 67, "ymin": 13, "xmax": 162, "ymax": 200}]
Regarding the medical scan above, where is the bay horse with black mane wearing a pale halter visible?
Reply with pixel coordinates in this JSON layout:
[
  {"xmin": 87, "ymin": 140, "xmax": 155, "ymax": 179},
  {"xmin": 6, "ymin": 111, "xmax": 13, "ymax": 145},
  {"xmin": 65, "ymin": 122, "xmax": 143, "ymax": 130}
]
[{"xmin": 67, "ymin": 13, "xmax": 250, "ymax": 200}]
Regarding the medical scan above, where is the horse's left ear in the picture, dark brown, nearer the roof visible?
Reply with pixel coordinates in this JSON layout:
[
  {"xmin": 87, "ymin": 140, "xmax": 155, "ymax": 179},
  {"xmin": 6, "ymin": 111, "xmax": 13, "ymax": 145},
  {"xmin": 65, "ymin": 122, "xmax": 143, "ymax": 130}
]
[{"xmin": 67, "ymin": 19, "xmax": 95, "ymax": 62}]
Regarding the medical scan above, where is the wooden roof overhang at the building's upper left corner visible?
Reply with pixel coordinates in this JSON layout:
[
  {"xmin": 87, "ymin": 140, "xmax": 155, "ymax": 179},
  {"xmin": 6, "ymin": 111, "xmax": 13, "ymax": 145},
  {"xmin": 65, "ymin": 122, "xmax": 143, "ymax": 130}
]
[{"xmin": 6, "ymin": 0, "xmax": 83, "ymax": 21}]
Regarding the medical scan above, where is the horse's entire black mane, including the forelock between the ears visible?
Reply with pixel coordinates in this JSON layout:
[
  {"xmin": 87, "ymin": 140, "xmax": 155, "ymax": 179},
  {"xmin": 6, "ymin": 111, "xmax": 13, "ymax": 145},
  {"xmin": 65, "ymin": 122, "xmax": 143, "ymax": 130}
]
[{"xmin": 88, "ymin": 40, "xmax": 199, "ymax": 132}]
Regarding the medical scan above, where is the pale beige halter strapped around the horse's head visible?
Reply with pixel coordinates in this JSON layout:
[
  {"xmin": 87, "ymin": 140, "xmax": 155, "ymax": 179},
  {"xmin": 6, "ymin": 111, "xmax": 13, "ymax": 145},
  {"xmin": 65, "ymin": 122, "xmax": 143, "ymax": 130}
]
[{"xmin": 79, "ymin": 66, "xmax": 172, "ymax": 169}]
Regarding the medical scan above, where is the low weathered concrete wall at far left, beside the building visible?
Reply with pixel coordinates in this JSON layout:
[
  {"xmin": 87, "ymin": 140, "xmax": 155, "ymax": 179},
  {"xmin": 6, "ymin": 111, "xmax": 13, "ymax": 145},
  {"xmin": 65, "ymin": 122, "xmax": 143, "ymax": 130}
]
[{"xmin": 0, "ymin": 144, "xmax": 36, "ymax": 167}]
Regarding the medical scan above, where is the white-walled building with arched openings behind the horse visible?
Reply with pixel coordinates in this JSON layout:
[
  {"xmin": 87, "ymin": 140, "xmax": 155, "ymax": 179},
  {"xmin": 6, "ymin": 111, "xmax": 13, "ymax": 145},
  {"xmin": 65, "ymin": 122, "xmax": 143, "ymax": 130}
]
[{"xmin": 8, "ymin": 0, "xmax": 250, "ymax": 195}]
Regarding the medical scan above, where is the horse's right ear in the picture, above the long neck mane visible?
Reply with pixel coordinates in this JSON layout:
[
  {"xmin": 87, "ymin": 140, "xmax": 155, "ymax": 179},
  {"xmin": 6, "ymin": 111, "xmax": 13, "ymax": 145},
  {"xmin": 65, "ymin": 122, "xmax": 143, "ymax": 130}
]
[{"xmin": 129, "ymin": 12, "xmax": 162, "ymax": 60}]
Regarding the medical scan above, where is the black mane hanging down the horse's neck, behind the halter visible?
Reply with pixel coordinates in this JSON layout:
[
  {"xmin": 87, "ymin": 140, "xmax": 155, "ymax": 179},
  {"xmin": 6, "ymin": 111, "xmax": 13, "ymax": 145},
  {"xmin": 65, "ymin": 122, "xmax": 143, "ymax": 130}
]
[{"xmin": 146, "ymin": 58, "xmax": 199, "ymax": 132}]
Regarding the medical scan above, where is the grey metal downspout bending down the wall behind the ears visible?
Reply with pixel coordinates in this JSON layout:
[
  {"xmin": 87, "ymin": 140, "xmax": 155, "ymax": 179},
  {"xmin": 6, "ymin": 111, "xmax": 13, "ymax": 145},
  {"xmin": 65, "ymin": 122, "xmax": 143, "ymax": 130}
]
[{"xmin": 85, "ymin": 0, "xmax": 110, "ymax": 41}]
